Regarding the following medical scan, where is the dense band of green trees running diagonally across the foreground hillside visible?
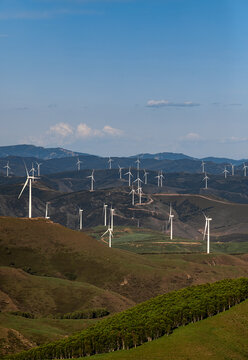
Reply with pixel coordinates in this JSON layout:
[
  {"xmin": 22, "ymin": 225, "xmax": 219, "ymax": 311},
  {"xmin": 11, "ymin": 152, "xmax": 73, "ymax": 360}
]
[{"xmin": 5, "ymin": 278, "xmax": 248, "ymax": 360}]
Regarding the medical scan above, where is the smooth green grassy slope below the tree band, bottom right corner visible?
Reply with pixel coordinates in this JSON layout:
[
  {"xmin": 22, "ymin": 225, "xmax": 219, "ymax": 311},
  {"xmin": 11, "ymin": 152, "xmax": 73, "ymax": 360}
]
[{"xmin": 74, "ymin": 300, "xmax": 248, "ymax": 360}]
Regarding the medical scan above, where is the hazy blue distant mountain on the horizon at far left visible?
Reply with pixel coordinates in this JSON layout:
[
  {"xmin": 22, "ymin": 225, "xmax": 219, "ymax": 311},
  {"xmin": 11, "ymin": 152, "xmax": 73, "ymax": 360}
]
[{"xmin": 0, "ymin": 145, "xmax": 87, "ymax": 160}]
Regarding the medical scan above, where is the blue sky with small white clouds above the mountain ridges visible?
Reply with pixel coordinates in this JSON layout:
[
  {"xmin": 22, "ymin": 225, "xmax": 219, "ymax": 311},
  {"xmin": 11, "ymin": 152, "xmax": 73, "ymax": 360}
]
[{"xmin": 0, "ymin": 0, "xmax": 248, "ymax": 158}]
